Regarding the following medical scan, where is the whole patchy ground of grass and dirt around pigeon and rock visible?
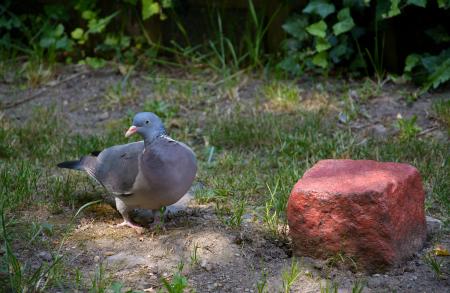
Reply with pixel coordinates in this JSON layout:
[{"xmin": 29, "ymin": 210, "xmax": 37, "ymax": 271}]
[{"xmin": 0, "ymin": 64, "xmax": 450, "ymax": 292}]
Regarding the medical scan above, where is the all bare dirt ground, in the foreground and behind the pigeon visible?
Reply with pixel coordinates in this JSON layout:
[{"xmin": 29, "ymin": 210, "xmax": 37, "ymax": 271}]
[{"xmin": 0, "ymin": 67, "xmax": 450, "ymax": 292}]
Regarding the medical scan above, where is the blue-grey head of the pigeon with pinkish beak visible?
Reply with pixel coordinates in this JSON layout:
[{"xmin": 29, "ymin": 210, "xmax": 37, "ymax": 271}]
[{"xmin": 125, "ymin": 112, "xmax": 166, "ymax": 141}]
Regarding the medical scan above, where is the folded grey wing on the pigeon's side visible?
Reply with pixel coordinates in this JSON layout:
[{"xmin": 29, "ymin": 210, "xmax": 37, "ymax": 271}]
[{"xmin": 92, "ymin": 141, "xmax": 144, "ymax": 194}]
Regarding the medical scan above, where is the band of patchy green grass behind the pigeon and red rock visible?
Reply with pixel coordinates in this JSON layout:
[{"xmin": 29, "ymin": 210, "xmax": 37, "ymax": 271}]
[{"xmin": 0, "ymin": 74, "xmax": 450, "ymax": 290}]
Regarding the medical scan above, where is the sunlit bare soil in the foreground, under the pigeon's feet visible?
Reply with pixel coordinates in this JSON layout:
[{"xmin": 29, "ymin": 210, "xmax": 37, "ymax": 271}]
[{"xmin": 15, "ymin": 196, "xmax": 450, "ymax": 292}]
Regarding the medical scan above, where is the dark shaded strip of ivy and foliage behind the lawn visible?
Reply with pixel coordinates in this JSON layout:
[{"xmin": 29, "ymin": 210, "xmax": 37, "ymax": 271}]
[{"xmin": 0, "ymin": 0, "xmax": 450, "ymax": 91}]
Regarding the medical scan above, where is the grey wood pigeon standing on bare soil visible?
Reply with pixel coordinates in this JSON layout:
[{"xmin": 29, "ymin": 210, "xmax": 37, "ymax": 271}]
[{"xmin": 57, "ymin": 112, "xmax": 197, "ymax": 229}]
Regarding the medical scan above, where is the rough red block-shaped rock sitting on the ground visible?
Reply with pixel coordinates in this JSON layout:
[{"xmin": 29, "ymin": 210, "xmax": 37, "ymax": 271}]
[{"xmin": 287, "ymin": 160, "xmax": 426, "ymax": 271}]
